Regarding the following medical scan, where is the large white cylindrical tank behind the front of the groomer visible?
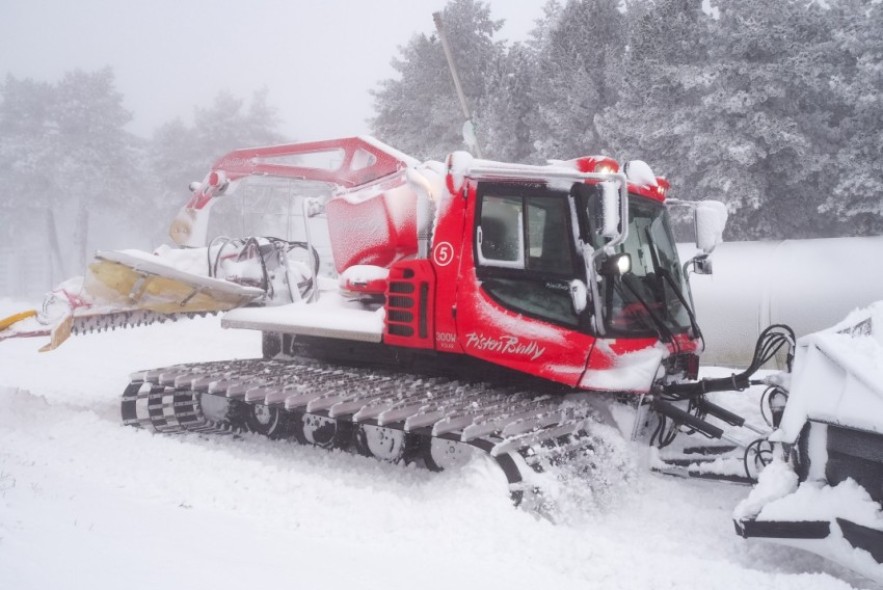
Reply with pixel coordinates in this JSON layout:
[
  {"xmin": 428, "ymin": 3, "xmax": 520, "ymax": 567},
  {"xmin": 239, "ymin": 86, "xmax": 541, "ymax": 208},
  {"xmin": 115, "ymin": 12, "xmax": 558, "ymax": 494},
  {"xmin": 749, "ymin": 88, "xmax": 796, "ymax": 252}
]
[{"xmin": 679, "ymin": 236, "xmax": 883, "ymax": 368}]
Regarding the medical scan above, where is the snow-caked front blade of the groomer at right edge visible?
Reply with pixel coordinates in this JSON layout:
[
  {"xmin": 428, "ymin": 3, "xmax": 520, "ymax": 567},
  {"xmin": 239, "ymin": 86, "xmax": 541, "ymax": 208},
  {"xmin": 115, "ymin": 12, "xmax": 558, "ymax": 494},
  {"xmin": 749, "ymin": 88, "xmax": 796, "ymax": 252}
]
[{"xmin": 734, "ymin": 302, "xmax": 883, "ymax": 582}]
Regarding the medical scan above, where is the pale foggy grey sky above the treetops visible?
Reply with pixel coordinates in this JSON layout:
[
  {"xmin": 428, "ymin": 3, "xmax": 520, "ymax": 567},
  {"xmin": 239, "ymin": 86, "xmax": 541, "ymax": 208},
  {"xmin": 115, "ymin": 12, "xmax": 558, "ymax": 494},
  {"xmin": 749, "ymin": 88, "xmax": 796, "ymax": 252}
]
[{"xmin": 0, "ymin": 0, "xmax": 546, "ymax": 140}]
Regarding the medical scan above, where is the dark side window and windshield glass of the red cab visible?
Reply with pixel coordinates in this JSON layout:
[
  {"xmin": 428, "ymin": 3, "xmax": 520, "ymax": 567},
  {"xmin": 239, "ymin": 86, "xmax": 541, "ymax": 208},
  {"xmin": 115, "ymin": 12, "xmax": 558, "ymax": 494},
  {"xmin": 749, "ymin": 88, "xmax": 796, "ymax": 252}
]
[{"xmin": 475, "ymin": 182, "xmax": 696, "ymax": 341}]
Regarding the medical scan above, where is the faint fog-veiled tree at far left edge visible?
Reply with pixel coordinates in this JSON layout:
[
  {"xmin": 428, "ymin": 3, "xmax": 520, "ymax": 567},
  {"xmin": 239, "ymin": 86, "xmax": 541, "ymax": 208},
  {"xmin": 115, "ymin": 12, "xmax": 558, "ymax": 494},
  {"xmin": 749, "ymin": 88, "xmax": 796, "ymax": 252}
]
[{"xmin": 0, "ymin": 68, "xmax": 138, "ymax": 281}]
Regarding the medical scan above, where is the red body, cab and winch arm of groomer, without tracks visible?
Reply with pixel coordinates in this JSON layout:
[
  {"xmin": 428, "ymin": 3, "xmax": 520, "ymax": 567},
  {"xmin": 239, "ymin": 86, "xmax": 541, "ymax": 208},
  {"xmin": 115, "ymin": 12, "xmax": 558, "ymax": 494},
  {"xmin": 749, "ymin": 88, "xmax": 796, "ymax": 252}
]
[{"xmin": 172, "ymin": 138, "xmax": 700, "ymax": 393}]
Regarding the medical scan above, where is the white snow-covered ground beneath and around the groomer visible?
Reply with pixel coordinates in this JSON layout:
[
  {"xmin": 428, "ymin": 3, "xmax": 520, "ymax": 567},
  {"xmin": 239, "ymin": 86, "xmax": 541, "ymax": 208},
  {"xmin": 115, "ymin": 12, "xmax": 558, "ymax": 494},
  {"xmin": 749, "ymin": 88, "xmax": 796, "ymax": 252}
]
[{"xmin": 0, "ymin": 300, "xmax": 876, "ymax": 590}]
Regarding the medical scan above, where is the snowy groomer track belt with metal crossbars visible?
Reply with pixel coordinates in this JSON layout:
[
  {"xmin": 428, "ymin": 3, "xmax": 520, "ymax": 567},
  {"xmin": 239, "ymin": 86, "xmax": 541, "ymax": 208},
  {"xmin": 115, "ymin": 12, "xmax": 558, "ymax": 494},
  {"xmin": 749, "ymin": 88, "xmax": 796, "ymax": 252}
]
[{"xmin": 121, "ymin": 359, "xmax": 594, "ymax": 504}]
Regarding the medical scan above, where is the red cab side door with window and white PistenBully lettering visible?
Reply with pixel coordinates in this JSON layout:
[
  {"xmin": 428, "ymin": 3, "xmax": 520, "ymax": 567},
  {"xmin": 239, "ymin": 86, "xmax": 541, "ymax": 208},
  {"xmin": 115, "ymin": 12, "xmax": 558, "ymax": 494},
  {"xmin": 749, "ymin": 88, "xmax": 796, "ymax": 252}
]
[{"xmin": 456, "ymin": 183, "xmax": 594, "ymax": 386}]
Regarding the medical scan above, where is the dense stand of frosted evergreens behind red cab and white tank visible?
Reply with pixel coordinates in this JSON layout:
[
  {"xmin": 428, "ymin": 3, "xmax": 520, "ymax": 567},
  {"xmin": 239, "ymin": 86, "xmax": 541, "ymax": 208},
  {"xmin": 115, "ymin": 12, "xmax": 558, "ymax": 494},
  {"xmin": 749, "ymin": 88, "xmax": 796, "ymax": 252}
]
[{"xmin": 373, "ymin": 0, "xmax": 883, "ymax": 239}]
